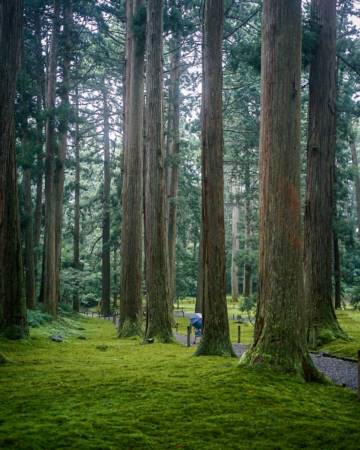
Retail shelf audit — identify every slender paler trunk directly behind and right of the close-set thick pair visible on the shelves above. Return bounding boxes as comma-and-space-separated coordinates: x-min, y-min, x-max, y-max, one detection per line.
167, 13, 181, 306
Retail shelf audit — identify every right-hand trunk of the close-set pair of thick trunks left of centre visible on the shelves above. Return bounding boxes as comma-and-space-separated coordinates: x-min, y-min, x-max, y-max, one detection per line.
145, 0, 172, 342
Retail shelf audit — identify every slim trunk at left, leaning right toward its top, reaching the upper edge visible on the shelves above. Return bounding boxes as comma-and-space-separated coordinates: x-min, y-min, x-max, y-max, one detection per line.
54, 0, 72, 302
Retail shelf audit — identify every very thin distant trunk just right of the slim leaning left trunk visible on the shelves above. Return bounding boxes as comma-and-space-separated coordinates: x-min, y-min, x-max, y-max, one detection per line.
73, 88, 81, 312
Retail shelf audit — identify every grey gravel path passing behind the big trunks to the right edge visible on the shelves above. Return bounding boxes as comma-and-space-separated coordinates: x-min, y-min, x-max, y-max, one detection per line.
175, 334, 358, 389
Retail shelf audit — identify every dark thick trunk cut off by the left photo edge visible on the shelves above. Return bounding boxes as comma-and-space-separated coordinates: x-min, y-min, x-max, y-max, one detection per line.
0, 0, 27, 339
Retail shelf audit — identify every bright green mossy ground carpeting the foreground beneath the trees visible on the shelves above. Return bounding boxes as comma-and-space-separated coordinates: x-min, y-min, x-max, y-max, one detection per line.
0, 315, 360, 450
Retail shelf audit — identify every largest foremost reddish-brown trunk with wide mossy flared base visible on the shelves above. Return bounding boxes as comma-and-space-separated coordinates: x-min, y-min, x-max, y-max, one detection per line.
243, 0, 317, 380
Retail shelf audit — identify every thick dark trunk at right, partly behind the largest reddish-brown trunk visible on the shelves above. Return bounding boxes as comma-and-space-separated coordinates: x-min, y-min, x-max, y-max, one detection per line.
304, 0, 344, 344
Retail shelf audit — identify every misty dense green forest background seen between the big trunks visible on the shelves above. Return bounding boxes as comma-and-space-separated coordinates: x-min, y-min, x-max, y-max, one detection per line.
9, 0, 360, 316
